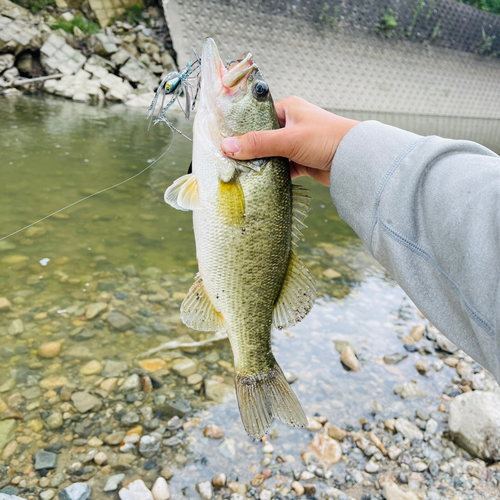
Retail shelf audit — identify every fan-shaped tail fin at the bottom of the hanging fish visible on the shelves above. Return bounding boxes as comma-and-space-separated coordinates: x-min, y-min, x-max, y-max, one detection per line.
235, 363, 307, 441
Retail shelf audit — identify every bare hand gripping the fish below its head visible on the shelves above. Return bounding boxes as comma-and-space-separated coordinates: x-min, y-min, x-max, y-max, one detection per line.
221, 97, 359, 186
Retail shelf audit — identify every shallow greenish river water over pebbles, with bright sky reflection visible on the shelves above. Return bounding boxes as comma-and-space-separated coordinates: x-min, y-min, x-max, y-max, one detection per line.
0, 97, 496, 497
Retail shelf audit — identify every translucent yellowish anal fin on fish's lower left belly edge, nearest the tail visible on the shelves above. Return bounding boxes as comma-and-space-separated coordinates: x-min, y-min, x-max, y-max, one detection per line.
181, 274, 224, 332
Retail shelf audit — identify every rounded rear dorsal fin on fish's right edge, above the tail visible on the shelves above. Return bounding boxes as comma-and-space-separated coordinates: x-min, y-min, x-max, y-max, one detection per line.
273, 250, 316, 330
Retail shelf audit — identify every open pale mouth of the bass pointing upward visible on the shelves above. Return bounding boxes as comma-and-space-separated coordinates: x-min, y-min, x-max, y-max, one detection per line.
201, 38, 257, 104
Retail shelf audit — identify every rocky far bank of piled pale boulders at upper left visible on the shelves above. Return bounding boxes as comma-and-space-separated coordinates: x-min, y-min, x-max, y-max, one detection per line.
0, 0, 175, 107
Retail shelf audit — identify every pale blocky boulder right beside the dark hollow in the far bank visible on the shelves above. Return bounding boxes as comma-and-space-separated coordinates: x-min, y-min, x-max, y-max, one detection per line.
40, 33, 87, 75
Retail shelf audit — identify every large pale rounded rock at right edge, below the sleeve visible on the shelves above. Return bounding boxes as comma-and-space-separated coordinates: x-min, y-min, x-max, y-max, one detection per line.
448, 391, 500, 461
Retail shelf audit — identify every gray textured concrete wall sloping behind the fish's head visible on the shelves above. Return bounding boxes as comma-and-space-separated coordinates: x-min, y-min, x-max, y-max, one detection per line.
164, 0, 500, 118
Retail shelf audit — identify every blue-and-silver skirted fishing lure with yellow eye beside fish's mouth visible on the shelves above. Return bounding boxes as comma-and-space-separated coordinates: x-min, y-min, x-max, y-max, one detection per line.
148, 48, 201, 140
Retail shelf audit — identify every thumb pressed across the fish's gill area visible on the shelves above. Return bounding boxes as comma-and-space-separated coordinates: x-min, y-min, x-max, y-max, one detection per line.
221, 128, 293, 160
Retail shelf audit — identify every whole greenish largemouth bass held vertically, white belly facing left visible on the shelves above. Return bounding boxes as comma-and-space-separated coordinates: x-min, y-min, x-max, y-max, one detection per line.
165, 39, 316, 439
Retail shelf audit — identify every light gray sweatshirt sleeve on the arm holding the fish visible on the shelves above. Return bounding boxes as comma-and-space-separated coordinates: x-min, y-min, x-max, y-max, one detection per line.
330, 121, 500, 381
